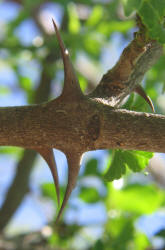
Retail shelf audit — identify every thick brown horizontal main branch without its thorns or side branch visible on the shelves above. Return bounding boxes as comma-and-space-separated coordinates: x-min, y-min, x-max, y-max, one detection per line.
0, 98, 165, 152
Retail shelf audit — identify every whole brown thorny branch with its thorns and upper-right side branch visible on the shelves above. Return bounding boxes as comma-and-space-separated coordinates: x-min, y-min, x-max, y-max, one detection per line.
0, 17, 165, 222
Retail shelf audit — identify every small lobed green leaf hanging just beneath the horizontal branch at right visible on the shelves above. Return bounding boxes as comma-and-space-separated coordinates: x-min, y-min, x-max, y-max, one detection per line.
104, 150, 153, 181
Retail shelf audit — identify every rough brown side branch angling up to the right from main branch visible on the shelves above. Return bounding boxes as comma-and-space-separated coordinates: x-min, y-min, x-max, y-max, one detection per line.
89, 17, 163, 107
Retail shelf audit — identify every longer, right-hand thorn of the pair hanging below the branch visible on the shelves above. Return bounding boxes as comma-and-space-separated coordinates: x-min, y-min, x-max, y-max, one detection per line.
55, 154, 81, 223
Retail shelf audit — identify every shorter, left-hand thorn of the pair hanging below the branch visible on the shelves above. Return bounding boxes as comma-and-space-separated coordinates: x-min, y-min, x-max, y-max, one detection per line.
37, 148, 60, 206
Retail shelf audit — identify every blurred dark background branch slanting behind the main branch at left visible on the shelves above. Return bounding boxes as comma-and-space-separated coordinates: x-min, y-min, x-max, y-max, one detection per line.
0, 52, 54, 231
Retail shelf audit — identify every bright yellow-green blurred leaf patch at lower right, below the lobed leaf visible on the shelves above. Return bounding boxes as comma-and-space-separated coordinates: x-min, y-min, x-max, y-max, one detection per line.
109, 184, 164, 214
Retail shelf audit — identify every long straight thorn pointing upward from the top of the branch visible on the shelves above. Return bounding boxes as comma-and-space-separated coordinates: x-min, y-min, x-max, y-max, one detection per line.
52, 19, 82, 97
